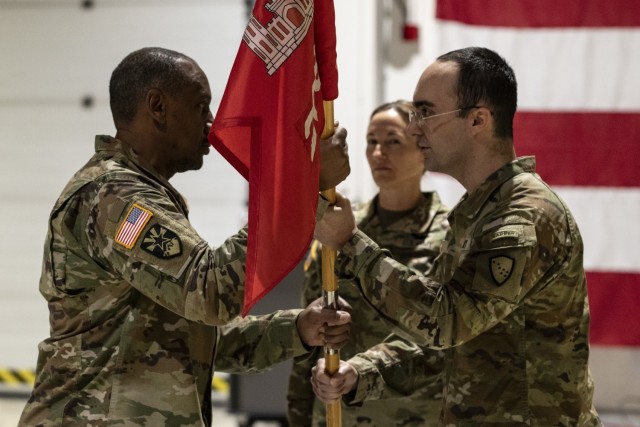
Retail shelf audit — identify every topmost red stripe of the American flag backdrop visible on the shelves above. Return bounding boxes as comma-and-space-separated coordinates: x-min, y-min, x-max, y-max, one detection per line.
436, 0, 640, 28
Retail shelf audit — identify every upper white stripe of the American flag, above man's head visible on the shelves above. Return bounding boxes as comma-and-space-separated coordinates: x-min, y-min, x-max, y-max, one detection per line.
437, 21, 640, 111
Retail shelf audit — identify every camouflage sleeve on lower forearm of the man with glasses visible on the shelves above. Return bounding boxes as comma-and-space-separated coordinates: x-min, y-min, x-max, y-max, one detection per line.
344, 334, 443, 406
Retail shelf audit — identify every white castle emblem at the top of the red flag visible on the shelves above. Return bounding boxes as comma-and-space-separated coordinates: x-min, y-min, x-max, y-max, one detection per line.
242, 0, 313, 75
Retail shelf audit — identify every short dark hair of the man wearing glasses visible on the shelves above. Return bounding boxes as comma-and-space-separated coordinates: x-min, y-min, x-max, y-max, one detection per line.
437, 47, 518, 138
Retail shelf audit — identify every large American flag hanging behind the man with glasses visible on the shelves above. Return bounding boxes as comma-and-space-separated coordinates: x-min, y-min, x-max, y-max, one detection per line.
425, 0, 640, 404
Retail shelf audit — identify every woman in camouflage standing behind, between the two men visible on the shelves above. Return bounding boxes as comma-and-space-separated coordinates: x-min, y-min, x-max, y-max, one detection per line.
287, 101, 449, 427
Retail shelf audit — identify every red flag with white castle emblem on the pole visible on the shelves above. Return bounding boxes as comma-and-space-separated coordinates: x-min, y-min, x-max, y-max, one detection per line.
209, 0, 338, 316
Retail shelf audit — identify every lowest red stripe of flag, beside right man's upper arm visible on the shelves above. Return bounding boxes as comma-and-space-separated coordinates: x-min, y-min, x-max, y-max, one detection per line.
587, 272, 640, 346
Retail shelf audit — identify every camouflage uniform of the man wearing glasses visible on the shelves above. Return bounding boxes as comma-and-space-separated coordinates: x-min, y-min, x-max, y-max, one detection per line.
337, 157, 601, 427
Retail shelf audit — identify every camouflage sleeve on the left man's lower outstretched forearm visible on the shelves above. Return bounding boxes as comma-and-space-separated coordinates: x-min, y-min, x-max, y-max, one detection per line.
215, 309, 308, 374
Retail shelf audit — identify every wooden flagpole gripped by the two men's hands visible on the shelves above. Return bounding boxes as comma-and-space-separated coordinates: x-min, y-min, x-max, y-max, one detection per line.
321, 101, 342, 427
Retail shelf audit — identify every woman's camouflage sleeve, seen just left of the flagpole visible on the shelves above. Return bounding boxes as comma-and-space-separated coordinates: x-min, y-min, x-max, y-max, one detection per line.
287, 241, 322, 427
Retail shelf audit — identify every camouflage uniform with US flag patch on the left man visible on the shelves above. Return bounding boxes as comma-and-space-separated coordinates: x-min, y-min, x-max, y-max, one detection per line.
20, 136, 316, 426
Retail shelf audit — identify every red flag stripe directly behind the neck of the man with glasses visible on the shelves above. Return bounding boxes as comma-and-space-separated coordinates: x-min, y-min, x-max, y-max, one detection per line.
514, 111, 640, 187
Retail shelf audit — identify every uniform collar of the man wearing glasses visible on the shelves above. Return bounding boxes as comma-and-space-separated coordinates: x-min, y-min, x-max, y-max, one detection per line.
449, 156, 536, 222
